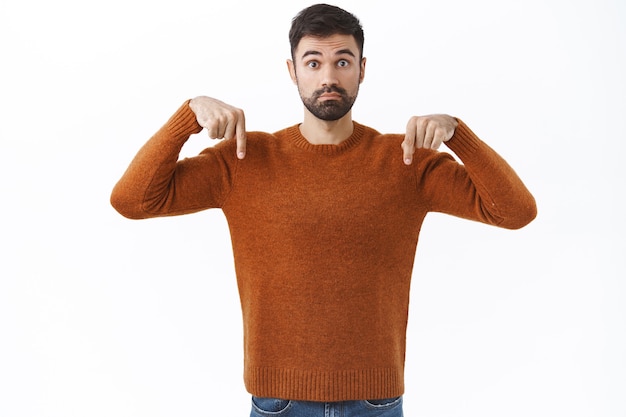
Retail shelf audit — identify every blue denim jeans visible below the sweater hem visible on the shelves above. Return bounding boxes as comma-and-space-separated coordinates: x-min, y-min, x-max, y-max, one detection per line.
250, 396, 403, 417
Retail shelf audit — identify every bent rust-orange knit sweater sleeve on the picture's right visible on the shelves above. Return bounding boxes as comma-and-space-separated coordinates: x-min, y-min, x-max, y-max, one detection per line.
418, 120, 537, 229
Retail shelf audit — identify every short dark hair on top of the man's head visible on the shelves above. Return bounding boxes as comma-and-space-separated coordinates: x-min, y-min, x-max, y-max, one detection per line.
289, 3, 364, 59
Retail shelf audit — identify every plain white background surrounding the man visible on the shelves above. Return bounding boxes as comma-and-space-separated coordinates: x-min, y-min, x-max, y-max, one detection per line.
0, 0, 626, 417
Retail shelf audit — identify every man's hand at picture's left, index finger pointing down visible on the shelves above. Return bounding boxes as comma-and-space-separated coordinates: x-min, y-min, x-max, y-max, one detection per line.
189, 96, 246, 159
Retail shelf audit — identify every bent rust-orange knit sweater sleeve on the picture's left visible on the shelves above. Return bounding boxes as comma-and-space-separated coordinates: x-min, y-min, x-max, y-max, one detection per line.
111, 101, 235, 219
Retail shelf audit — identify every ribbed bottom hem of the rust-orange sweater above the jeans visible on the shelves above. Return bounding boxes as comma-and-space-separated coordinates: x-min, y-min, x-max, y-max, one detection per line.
244, 367, 404, 402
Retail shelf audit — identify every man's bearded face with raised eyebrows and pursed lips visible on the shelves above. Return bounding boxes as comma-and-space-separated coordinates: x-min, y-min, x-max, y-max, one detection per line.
288, 35, 365, 121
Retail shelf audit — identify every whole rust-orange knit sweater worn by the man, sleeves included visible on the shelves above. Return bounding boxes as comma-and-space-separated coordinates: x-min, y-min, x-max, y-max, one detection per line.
111, 103, 536, 401
